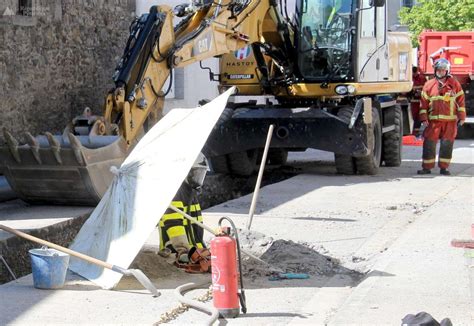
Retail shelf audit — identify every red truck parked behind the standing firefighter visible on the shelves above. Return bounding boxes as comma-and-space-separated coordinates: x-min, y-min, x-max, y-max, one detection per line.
418, 30, 474, 138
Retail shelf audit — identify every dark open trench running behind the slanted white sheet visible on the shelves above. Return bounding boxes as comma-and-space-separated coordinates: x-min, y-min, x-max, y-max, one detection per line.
0, 167, 296, 284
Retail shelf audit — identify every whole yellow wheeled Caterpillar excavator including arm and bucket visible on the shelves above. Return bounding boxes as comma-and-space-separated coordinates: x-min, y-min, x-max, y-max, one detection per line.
0, 0, 412, 205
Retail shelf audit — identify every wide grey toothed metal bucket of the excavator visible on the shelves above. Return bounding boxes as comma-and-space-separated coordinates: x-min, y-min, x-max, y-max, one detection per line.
0, 130, 130, 206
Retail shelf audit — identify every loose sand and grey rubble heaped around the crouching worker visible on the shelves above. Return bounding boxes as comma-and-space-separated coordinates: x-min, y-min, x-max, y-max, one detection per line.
115, 230, 366, 290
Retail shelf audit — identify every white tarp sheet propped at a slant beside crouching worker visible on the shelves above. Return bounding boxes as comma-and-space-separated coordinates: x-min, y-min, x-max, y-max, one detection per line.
69, 89, 233, 289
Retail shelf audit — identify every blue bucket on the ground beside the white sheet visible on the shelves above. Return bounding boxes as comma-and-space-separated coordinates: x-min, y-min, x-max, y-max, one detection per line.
29, 247, 69, 289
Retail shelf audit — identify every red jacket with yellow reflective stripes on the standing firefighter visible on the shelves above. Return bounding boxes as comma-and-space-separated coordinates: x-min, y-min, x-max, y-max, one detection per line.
420, 76, 466, 121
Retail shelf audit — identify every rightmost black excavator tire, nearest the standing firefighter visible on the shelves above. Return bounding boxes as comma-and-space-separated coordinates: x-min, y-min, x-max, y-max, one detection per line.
382, 105, 403, 166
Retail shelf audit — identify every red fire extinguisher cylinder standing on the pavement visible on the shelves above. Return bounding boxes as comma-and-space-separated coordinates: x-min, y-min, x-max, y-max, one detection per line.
211, 235, 240, 318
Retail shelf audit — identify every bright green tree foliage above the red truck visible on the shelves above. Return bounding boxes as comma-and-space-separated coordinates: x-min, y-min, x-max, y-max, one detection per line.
399, 0, 474, 46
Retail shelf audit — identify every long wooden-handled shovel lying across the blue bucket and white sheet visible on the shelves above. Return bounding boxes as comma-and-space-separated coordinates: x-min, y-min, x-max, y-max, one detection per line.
0, 224, 160, 297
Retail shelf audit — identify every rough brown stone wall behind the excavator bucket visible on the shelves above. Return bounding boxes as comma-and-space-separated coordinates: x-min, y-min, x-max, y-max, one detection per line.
0, 0, 135, 138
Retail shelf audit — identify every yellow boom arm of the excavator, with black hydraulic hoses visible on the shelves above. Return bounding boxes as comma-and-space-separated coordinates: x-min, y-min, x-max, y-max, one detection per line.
109, 0, 279, 144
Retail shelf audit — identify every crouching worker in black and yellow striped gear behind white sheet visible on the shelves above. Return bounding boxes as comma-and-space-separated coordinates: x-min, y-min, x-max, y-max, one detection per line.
159, 154, 211, 273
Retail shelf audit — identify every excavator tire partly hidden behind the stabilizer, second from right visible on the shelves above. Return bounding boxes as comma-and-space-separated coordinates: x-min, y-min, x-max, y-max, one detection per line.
355, 108, 382, 175
